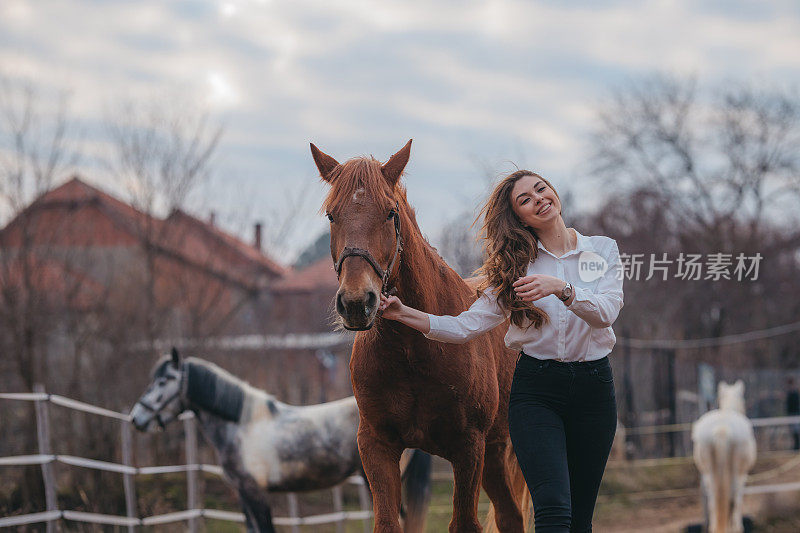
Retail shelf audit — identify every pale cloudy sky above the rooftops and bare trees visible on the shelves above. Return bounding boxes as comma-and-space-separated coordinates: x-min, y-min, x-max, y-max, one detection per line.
0, 0, 800, 257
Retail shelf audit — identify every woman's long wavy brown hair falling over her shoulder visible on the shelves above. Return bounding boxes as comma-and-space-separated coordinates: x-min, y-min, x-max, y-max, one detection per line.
476, 170, 561, 329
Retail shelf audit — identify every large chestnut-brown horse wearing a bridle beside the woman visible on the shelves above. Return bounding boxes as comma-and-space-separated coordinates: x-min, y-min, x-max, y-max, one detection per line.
311, 141, 529, 533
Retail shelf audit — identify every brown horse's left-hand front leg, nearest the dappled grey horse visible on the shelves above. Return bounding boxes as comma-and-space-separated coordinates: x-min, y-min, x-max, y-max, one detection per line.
358, 421, 403, 533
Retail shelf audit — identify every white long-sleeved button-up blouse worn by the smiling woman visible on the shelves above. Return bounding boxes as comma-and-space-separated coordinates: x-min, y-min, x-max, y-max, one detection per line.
425, 230, 623, 361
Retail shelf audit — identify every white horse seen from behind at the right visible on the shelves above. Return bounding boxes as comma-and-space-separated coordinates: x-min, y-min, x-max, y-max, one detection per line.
692, 380, 756, 533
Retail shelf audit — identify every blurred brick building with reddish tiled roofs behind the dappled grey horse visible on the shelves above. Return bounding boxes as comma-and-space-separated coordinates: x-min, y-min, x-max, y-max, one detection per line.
0, 177, 350, 403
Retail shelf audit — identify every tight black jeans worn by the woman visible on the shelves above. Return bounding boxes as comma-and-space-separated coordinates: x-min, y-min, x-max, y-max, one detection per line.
508, 354, 617, 533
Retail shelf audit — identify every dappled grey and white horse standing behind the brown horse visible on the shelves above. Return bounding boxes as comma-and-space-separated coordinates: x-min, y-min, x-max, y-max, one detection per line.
131, 348, 431, 533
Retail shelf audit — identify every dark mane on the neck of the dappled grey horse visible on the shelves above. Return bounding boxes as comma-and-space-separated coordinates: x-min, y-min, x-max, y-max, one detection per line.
183, 357, 248, 422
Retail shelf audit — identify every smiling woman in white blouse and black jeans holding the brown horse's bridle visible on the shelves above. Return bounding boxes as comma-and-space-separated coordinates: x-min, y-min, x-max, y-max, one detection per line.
380, 170, 623, 533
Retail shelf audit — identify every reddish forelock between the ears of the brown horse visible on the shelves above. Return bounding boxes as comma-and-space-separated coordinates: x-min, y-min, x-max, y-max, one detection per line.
322, 156, 406, 213
